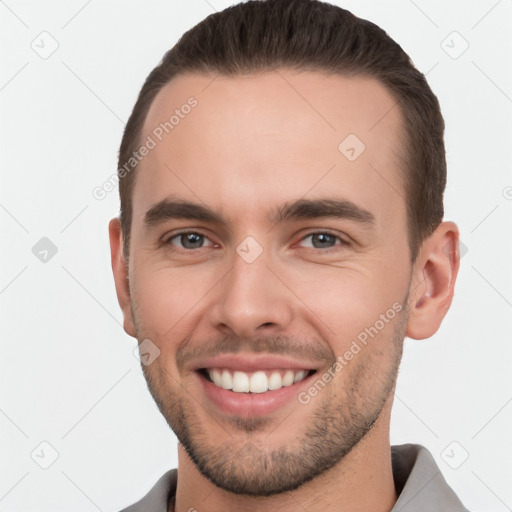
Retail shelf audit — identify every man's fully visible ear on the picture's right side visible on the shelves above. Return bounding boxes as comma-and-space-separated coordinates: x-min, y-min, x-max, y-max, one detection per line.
405, 222, 460, 339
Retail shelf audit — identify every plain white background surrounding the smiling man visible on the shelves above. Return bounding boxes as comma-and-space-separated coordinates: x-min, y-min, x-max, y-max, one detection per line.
0, 0, 512, 512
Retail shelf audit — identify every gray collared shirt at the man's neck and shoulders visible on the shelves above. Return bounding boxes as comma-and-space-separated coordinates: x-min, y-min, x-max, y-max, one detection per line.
122, 444, 468, 512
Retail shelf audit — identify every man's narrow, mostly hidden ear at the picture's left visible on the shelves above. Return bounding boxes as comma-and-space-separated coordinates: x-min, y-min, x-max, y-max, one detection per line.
108, 217, 136, 338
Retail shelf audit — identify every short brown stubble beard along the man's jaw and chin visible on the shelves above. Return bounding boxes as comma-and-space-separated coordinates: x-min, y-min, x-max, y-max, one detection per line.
132, 302, 407, 496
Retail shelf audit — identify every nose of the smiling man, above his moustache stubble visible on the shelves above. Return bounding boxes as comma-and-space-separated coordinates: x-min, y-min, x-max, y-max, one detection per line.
209, 250, 293, 337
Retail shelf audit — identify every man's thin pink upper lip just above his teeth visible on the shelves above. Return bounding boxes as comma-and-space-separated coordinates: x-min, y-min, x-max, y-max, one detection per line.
192, 354, 318, 372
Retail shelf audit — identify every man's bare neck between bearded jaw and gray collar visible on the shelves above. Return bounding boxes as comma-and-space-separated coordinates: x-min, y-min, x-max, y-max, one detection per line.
170, 403, 397, 512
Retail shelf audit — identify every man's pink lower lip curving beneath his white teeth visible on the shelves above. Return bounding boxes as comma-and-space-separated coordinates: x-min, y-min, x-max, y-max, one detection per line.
197, 373, 314, 418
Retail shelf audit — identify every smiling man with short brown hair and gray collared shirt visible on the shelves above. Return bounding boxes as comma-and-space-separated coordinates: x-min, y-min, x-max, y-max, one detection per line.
109, 0, 466, 512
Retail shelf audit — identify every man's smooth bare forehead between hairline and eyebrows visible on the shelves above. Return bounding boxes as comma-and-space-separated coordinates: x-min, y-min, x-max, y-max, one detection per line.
133, 69, 403, 228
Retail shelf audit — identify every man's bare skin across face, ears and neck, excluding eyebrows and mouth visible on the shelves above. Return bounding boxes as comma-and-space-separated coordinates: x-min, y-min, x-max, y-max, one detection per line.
109, 69, 459, 512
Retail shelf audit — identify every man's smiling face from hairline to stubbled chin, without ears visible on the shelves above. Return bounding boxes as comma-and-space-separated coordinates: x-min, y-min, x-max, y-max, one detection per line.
125, 70, 411, 495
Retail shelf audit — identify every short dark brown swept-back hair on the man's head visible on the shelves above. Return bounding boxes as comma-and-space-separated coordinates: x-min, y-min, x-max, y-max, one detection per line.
118, 0, 446, 261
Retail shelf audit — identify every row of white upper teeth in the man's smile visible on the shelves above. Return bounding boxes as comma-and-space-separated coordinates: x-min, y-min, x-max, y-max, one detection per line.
208, 368, 307, 393
